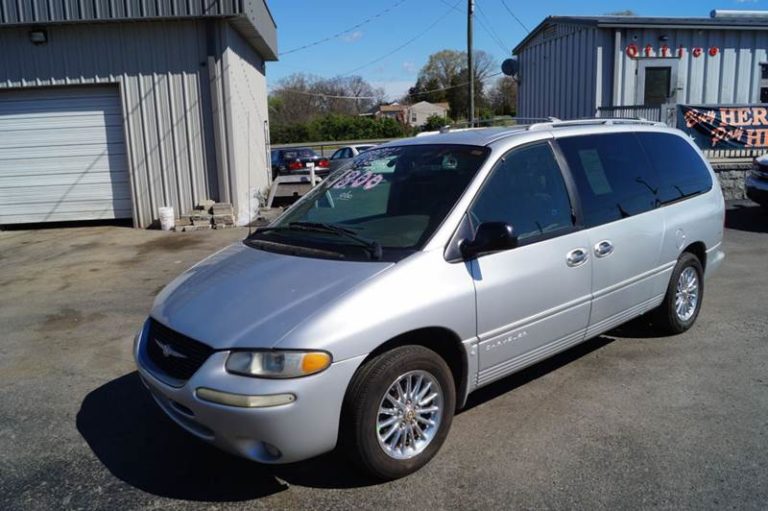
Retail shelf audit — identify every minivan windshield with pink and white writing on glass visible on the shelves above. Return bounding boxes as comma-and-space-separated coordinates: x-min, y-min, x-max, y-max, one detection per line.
249, 144, 490, 260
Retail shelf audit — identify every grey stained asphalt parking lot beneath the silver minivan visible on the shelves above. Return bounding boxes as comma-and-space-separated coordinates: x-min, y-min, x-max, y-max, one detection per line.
0, 203, 768, 510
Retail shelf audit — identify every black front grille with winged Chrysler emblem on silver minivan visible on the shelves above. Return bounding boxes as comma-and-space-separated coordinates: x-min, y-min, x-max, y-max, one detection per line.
147, 318, 213, 380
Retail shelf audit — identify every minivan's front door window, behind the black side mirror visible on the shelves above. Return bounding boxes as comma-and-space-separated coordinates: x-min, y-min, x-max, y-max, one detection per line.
469, 143, 573, 244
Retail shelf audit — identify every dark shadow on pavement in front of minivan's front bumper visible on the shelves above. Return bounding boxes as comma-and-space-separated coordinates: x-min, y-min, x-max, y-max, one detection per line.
77, 372, 375, 502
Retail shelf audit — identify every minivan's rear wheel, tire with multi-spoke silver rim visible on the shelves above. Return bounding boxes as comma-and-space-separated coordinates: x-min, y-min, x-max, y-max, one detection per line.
653, 252, 704, 334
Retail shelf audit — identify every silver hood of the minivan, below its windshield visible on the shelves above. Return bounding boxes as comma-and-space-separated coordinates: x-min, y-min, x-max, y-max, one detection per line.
151, 243, 394, 349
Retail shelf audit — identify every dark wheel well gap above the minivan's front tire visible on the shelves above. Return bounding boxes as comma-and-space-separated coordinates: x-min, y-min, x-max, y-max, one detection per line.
363, 327, 467, 409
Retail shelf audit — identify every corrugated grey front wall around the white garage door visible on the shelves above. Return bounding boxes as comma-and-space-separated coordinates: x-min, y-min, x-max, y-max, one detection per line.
0, 21, 216, 227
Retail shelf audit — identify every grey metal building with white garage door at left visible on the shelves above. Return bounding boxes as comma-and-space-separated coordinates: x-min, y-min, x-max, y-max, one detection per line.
0, 0, 277, 227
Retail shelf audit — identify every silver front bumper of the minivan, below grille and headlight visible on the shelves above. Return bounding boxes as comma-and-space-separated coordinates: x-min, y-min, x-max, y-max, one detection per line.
134, 327, 365, 463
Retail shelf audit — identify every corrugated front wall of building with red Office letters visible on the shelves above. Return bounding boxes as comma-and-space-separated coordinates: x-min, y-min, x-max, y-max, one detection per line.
616, 29, 768, 105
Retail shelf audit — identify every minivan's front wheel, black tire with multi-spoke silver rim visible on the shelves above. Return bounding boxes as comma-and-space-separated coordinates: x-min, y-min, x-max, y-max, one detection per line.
341, 346, 456, 480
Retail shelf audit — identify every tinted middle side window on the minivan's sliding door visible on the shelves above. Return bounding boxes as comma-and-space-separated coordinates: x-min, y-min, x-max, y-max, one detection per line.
557, 133, 658, 227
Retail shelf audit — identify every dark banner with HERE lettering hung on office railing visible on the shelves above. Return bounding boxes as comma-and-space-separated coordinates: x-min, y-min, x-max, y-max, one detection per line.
677, 105, 768, 149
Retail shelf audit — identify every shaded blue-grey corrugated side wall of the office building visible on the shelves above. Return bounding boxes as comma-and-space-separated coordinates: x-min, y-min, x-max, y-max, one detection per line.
517, 24, 612, 119
